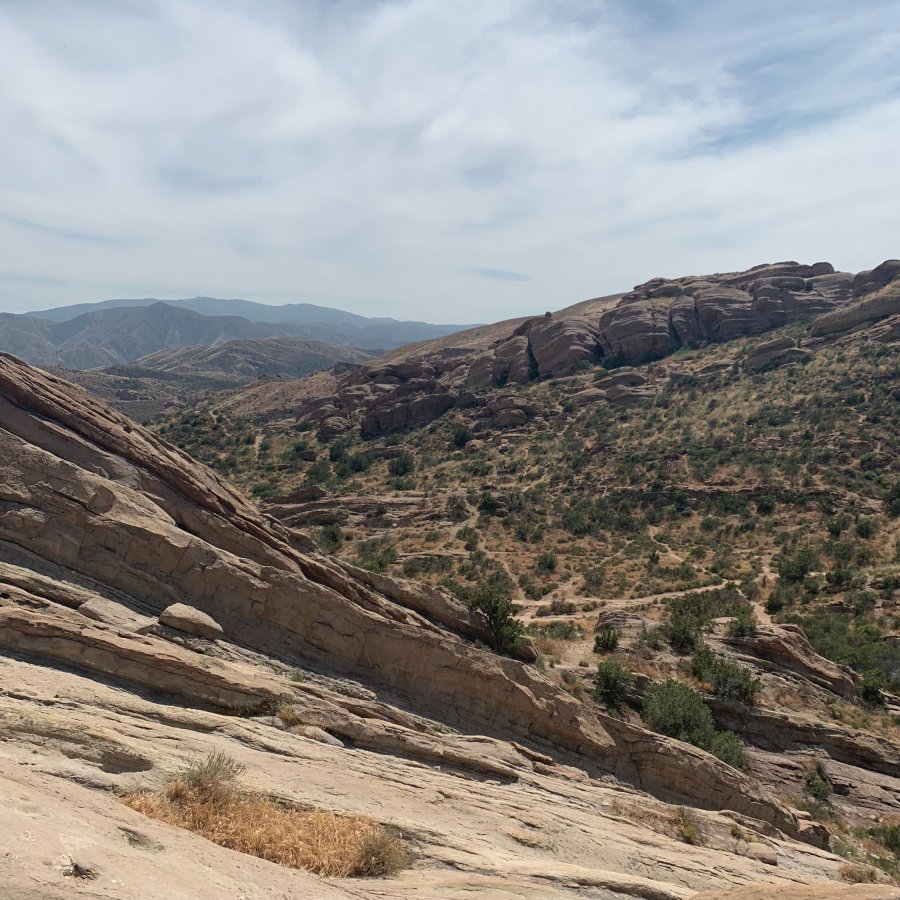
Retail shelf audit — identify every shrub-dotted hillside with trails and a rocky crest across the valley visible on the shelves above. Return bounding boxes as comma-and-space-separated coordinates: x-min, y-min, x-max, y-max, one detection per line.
144, 262, 900, 875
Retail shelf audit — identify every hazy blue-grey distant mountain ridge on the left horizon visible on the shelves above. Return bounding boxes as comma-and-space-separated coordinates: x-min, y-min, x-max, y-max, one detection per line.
0, 297, 478, 369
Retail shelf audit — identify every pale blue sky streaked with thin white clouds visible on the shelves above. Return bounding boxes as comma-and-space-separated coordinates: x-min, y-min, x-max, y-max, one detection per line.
0, 0, 900, 323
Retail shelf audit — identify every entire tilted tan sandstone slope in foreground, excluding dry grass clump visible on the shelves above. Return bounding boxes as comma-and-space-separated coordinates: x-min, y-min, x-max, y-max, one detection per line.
0, 356, 897, 900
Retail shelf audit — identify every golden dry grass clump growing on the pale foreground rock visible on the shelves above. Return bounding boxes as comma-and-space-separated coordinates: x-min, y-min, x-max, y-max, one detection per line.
124, 754, 410, 878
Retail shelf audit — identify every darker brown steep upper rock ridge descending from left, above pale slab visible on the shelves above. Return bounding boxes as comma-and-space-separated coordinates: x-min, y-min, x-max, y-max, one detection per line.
0, 357, 800, 834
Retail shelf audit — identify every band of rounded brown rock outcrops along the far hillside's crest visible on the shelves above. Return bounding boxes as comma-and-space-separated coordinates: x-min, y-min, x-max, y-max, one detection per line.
276, 260, 900, 441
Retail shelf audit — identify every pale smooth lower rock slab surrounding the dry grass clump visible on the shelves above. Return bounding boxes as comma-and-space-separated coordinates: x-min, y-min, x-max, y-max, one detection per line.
0, 656, 864, 900
